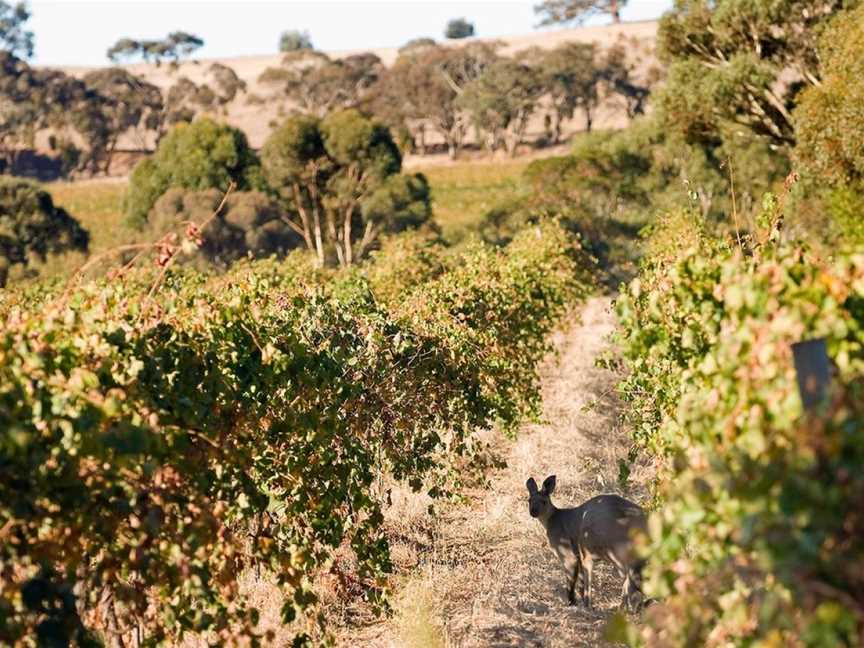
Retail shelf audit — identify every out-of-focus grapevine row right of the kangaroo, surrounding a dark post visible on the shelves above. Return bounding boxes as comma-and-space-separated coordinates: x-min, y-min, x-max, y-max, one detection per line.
616, 201, 864, 648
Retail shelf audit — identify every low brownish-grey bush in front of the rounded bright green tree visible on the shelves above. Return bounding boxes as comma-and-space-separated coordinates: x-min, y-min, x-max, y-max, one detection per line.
147, 187, 300, 267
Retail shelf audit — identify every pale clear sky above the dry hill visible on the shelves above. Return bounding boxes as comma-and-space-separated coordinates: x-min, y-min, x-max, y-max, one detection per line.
29, 0, 672, 66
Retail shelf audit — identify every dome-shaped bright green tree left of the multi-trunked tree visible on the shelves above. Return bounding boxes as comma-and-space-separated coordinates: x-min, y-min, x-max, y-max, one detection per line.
125, 118, 262, 226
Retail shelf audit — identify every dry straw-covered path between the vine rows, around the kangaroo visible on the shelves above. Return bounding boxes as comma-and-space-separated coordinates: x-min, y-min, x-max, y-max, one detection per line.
340, 297, 650, 648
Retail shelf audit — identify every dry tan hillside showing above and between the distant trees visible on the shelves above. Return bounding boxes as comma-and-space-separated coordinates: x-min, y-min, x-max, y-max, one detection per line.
64, 21, 657, 148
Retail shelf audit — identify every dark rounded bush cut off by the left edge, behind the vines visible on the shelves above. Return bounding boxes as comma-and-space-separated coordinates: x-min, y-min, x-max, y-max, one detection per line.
0, 177, 90, 287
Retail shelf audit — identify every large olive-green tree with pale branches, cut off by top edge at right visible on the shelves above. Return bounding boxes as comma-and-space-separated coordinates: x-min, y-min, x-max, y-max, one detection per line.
658, 0, 850, 148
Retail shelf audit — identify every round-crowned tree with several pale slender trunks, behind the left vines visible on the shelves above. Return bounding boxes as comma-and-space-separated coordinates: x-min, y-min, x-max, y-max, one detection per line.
261, 110, 430, 265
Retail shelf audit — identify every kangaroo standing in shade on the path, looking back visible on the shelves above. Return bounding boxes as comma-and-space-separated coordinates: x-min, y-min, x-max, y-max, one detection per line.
525, 475, 646, 609
